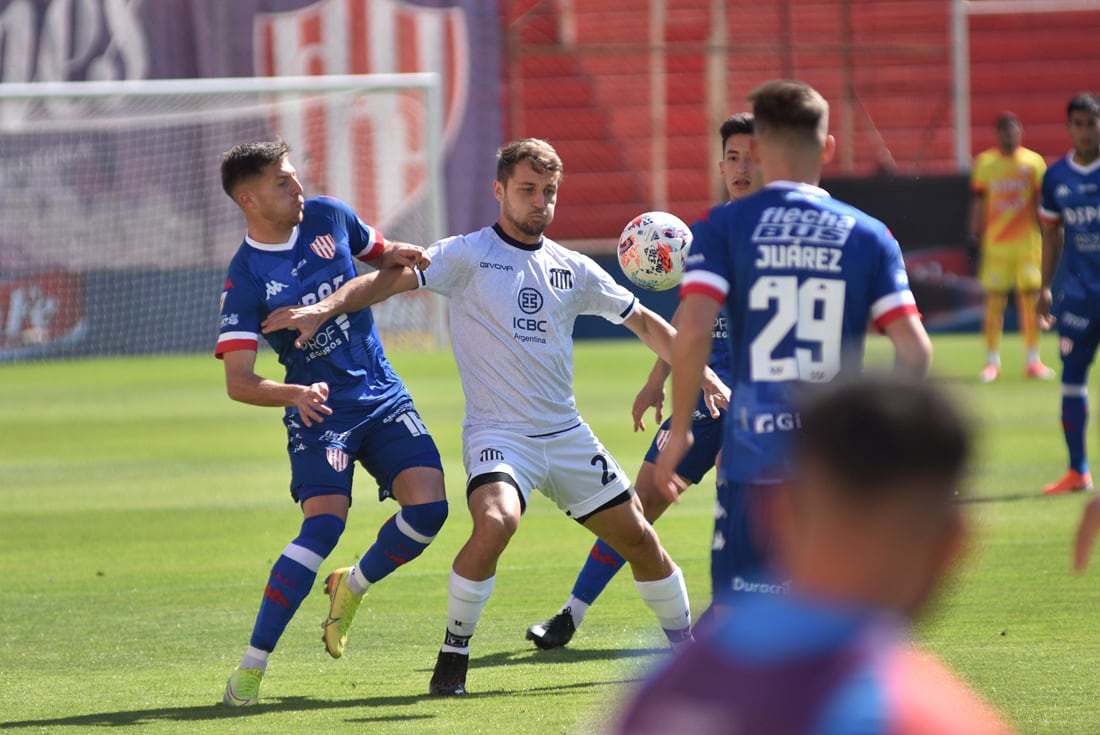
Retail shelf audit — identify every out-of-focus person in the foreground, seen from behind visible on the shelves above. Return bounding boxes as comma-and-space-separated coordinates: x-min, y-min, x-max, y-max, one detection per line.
614, 373, 1010, 735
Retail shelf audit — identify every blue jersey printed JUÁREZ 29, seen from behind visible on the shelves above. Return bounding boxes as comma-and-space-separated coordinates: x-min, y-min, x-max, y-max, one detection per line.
680, 182, 917, 482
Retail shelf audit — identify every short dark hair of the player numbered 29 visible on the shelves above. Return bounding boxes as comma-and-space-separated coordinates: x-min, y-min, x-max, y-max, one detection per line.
748, 79, 828, 145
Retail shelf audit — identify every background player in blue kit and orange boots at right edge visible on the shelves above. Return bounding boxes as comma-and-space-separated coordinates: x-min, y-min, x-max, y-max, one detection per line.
1036, 92, 1100, 495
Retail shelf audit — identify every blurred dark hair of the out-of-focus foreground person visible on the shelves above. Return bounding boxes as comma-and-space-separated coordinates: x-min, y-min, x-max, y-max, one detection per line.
795, 376, 972, 503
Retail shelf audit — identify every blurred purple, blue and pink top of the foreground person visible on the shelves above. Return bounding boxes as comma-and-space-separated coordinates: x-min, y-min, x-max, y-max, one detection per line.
614, 596, 1011, 735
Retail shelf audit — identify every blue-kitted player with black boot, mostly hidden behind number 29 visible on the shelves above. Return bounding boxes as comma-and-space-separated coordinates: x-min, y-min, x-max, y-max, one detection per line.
527, 112, 759, 650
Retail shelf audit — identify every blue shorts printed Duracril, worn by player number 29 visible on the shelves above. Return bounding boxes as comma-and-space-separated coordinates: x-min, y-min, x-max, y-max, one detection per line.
711, 482, 790, 605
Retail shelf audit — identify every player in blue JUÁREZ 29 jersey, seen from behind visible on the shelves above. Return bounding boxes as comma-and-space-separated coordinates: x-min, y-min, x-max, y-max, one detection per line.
657, 80, 932, 599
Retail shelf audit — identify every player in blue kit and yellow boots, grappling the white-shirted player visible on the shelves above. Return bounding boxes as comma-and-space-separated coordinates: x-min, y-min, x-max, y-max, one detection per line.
216, 142, 447, 707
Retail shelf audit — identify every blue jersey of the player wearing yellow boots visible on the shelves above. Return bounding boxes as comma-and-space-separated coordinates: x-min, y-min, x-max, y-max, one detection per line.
215, 197, 405, 419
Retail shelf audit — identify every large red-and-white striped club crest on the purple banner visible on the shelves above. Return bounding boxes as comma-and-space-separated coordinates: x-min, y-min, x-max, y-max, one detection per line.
253, 0, 470, 230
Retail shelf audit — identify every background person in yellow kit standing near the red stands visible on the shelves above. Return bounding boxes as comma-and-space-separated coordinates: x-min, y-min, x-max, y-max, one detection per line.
969, 112, 1054, 383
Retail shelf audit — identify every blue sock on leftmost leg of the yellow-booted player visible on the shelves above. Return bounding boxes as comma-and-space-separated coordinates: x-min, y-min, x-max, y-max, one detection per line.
249, 515, 344, 651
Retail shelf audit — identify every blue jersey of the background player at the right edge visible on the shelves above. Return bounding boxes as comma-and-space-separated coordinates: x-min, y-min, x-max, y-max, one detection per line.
1040, 152, 1100, 308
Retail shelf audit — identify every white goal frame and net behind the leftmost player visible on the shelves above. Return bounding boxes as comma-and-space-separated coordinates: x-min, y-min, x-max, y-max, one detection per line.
0, 74, 446, 362
